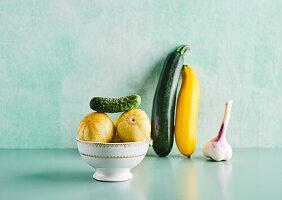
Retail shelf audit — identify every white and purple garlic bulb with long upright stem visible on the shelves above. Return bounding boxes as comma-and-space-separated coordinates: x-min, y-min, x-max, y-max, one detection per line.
203, 100, 232, 161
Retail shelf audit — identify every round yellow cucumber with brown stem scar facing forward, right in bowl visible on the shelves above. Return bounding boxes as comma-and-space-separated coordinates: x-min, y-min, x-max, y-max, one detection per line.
116, 109, 151, 142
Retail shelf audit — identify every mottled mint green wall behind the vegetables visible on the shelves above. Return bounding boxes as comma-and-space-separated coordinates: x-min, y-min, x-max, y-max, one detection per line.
0, 0, 282, 148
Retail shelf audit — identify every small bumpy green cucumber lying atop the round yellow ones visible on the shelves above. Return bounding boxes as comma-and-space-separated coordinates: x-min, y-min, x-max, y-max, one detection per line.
90, 94, 141, 113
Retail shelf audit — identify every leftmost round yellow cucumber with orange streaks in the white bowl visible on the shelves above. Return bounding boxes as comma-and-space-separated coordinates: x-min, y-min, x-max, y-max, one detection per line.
77, 112, 115, 142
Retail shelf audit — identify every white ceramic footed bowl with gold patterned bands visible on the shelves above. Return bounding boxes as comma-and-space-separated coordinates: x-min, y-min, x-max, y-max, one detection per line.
76, 138, 150, 181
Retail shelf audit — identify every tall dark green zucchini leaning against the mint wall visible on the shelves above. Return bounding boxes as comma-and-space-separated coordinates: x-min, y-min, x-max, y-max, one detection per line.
152, 45, 189, 156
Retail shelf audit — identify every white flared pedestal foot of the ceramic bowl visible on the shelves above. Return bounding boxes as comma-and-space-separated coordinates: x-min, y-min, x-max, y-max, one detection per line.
93, 168, 133, 181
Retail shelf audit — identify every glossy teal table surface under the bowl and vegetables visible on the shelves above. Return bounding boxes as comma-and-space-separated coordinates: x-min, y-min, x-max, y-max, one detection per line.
0, 149, 282, 200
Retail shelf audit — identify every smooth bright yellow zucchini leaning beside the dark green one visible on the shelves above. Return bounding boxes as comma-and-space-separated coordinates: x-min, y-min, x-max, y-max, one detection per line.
175, 65, 200, 157
